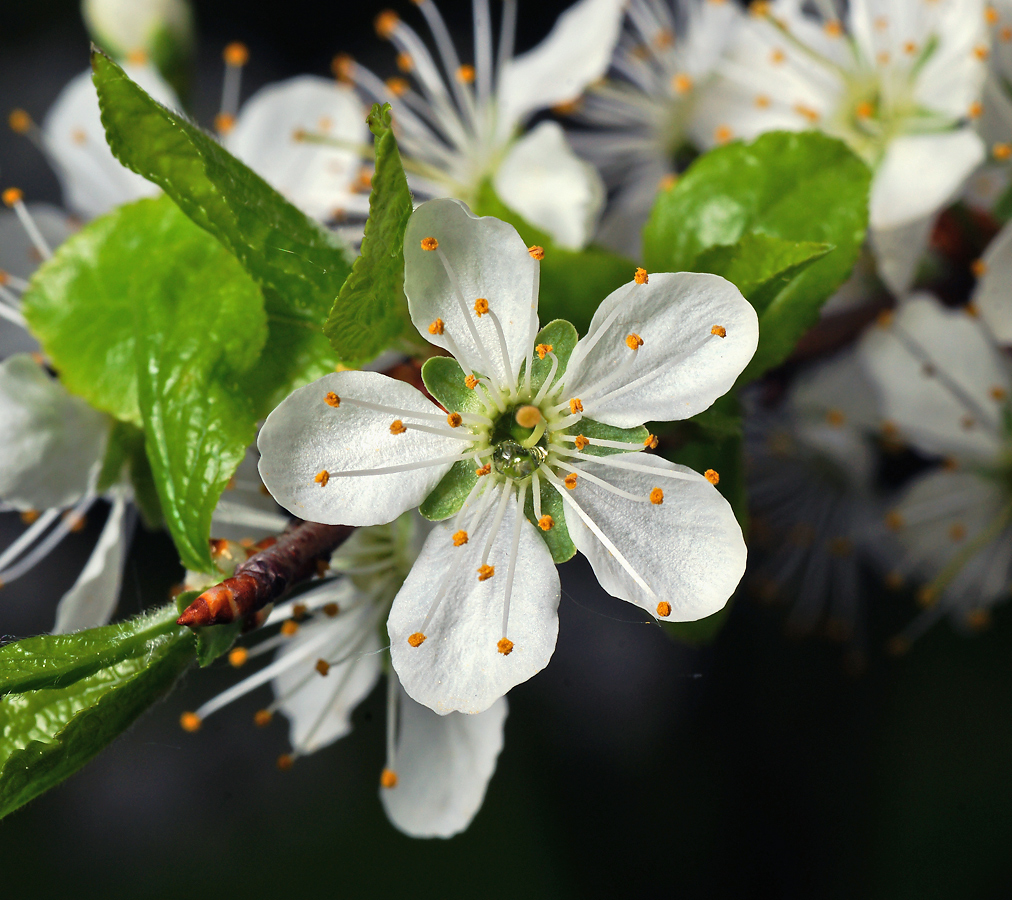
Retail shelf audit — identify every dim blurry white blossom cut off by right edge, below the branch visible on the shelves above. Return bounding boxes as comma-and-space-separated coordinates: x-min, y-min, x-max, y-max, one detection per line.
861, 295, 1012, 649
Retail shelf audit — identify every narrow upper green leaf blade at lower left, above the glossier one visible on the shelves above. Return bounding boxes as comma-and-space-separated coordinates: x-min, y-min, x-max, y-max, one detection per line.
0, 605, 178, 696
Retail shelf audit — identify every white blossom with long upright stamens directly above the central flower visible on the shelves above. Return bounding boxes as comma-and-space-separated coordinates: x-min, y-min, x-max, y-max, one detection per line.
335, 0, 622, 248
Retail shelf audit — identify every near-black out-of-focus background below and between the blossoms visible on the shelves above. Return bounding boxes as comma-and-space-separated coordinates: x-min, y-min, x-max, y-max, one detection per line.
0, 0, 1012, 900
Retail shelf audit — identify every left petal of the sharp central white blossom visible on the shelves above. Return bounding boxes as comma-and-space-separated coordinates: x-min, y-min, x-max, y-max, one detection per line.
257, 372, 468, 525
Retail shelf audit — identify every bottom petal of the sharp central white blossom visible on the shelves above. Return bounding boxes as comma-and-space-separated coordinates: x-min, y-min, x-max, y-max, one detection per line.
387, 487, 561, 716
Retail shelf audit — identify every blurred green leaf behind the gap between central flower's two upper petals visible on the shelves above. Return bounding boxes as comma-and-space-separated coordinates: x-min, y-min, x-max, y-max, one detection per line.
475, 182, 636, 334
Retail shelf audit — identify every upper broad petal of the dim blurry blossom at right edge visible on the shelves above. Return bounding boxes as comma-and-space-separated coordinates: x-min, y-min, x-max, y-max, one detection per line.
860, 295, 1012, 460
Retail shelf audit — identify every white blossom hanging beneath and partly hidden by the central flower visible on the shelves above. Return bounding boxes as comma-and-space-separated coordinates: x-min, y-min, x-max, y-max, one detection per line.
181, 513, 507, 837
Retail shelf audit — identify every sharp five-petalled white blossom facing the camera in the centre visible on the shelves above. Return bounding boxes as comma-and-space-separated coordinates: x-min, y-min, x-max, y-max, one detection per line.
259, 199, 758, 714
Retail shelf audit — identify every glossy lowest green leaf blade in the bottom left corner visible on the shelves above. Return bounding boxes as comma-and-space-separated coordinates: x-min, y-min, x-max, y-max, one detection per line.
0, 619, 193, 818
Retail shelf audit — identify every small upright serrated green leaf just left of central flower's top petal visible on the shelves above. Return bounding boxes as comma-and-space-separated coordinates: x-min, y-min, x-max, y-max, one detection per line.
324, 103, 415, 365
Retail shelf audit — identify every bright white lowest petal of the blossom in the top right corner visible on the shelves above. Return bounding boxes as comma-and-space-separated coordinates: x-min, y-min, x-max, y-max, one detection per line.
868, 128, 985, 230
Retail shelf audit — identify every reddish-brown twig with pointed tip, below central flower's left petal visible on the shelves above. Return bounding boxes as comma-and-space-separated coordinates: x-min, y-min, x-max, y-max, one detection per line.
176, 522, 354, 627
